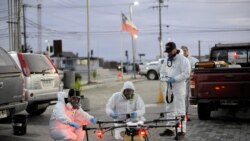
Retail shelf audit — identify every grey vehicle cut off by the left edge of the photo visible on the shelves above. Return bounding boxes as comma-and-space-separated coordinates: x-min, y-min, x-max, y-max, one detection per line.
0, 47, 28, 119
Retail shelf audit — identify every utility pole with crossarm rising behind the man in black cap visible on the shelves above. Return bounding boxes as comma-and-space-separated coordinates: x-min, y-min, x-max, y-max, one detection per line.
153, 0, 168, 58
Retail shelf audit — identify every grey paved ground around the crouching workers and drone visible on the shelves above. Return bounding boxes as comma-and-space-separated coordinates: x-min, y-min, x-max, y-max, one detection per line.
0, 79, 250, 141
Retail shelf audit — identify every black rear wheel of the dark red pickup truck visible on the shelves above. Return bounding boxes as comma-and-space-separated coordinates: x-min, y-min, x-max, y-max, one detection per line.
198, 103, 211, 120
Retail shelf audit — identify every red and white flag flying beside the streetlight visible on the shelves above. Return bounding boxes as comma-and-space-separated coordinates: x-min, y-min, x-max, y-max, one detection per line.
122, 13, 138, 37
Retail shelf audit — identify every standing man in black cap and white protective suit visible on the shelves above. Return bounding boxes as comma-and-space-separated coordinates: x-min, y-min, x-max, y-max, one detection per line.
159, 42, 190, 139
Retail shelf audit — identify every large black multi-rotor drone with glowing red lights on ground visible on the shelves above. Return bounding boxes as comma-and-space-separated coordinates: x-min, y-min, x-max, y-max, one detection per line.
83, 113, 184, 141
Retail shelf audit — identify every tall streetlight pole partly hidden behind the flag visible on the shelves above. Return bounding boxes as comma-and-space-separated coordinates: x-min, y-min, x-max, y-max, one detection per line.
129, 1, 139, 78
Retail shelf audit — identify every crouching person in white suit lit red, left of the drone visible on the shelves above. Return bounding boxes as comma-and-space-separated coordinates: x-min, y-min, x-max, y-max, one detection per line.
49, 89, 97, 141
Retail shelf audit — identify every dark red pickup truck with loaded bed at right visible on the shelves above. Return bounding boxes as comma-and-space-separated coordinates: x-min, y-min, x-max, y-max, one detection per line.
190, 43, 250, 120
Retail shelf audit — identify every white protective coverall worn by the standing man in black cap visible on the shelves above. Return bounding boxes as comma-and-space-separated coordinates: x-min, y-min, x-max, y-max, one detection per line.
160, 54, 191, 132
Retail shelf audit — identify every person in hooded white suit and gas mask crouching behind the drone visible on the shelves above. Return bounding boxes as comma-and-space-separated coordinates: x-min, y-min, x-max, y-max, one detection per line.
106, 81, 145, 140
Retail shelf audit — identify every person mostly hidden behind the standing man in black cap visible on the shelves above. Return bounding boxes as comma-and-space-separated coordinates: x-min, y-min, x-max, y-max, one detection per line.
181, 46, 199, 121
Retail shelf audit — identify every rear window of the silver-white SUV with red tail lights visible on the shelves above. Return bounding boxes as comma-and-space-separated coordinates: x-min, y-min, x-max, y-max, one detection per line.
24, 54, 55, 73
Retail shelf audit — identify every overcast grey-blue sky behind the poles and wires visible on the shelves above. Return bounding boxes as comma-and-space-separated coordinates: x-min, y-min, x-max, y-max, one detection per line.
0, 0, 250, 60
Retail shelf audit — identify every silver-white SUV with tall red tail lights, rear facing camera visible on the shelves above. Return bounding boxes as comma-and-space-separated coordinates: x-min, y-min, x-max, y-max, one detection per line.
9, 52, 61, 115
